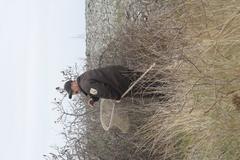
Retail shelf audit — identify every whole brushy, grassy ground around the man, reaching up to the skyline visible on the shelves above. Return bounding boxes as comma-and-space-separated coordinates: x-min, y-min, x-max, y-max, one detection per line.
74, 0, 240, 160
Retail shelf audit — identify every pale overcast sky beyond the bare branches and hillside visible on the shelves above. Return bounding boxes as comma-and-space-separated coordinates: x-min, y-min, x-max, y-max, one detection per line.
0, 0, 85, 160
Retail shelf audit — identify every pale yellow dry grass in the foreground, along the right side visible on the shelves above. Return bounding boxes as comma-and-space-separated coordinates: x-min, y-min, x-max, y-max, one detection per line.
132, 0, 240, 159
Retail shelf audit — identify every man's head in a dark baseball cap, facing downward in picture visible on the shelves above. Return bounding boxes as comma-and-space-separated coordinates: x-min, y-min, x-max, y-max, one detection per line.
64, 80, 80, 99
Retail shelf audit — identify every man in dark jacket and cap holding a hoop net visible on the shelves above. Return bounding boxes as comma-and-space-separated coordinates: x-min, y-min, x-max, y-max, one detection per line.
64, 65, 134, 106
